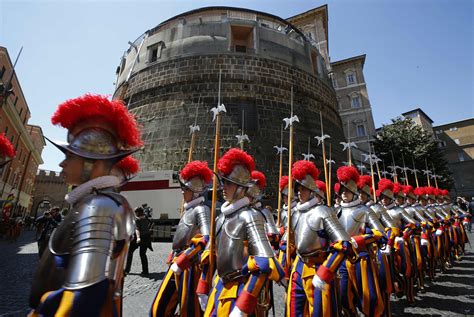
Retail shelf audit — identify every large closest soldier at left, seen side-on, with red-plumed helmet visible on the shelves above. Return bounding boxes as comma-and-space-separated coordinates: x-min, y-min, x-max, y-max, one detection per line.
30, 94, 142, 316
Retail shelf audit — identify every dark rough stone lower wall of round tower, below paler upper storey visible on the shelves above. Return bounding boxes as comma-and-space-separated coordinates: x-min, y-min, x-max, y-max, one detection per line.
120, 53, 345, 198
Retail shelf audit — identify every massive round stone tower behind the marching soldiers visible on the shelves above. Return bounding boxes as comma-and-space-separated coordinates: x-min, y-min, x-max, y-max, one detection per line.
114, 7, 344, 199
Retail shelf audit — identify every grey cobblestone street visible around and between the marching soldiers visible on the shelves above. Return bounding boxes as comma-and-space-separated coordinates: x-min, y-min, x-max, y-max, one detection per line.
0, 231, 474, 316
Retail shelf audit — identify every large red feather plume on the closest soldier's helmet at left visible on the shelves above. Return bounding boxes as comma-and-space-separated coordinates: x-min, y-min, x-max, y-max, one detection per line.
51, 94, 143, 147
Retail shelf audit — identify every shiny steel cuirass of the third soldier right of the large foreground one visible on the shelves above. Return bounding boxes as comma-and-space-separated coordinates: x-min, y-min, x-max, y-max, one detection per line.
291, 204, 349, 256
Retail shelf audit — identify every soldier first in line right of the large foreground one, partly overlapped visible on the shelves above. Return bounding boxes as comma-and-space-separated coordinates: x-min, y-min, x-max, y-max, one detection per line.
150, 161, 212, 317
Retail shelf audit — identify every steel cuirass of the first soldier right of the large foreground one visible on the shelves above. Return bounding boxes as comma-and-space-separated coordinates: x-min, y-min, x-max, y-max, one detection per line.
173, 203, 210, 252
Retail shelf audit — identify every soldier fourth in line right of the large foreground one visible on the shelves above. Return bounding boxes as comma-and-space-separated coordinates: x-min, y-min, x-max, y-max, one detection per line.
337, 166, 386, 316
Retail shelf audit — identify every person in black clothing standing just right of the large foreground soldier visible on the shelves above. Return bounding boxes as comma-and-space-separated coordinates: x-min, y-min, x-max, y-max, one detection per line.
125, 207, 153, 275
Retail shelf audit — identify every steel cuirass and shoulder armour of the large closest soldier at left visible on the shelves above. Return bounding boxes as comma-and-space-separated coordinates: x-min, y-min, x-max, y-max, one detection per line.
49, 190, 135, 290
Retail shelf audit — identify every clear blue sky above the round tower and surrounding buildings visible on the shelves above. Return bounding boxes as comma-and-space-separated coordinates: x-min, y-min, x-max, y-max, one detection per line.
0, 0, 474, 170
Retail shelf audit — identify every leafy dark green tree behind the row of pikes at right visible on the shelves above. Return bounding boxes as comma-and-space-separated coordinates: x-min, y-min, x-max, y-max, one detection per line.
374, 117, 453, 189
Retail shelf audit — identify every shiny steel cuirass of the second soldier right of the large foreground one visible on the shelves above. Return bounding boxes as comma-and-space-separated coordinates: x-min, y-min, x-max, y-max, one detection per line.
216, 206, 274, 278
